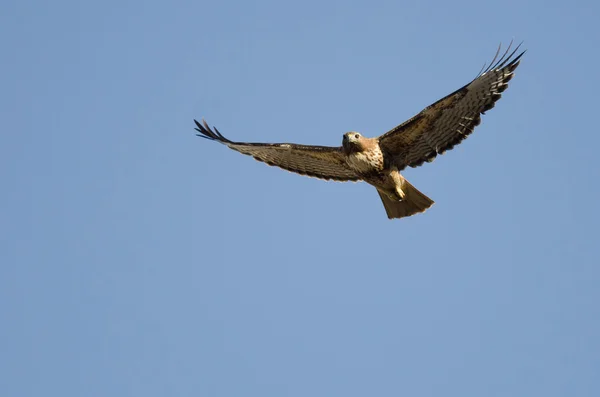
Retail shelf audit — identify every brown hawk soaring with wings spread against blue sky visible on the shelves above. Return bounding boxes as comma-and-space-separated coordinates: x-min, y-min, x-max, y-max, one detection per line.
194, 45, 525, 219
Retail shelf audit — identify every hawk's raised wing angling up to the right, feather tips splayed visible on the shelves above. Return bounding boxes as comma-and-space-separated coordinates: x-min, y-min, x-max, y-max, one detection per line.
379, 44, 525, 170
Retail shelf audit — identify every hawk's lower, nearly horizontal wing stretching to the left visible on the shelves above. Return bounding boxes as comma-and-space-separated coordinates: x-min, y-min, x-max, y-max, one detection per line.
194, 120, 360, 181
